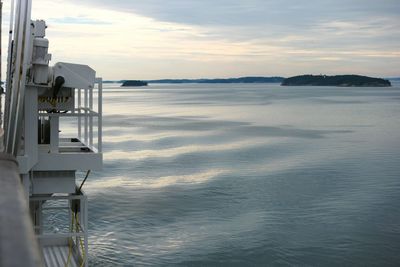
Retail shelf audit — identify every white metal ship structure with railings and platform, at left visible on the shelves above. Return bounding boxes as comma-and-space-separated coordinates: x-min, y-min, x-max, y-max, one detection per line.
4, 0, 102, 266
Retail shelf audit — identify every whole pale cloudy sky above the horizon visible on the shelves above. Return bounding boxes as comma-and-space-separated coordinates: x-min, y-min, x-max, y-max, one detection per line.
2, 0, 400, 79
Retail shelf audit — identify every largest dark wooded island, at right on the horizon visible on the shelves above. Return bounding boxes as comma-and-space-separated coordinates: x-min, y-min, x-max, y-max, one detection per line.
281, 75, 392, 87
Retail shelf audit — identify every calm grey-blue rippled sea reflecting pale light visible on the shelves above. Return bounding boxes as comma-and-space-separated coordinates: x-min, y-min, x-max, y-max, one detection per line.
85, 84, 400, 266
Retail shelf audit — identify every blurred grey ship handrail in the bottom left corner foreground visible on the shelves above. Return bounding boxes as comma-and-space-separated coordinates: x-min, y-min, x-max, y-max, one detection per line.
0, 153, 43, 267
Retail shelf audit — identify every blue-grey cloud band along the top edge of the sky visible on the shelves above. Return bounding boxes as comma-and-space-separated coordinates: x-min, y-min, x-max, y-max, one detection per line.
69, 0, 400, 28
